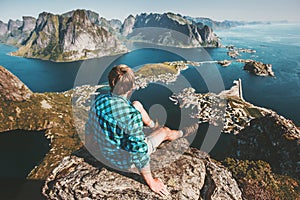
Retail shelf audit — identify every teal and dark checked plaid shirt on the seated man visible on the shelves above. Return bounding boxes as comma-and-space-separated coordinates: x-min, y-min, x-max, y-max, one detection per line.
86, 94, 150, 170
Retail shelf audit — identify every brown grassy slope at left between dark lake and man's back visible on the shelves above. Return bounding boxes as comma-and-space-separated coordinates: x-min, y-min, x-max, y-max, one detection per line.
0, 67, 82, 180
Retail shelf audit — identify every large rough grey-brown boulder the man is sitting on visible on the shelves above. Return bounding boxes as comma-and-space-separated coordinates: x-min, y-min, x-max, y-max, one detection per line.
43, 139, 242, 199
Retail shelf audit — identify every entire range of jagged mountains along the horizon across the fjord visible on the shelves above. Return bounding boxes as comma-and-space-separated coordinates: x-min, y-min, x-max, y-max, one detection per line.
0, 10, 278, 62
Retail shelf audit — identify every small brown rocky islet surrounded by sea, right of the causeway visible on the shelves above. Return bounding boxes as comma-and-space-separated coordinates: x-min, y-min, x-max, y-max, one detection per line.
244, 60, 274, 76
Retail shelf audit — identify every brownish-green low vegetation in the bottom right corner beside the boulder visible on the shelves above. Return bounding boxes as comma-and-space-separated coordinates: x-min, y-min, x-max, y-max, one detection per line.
222, 158, 300, 199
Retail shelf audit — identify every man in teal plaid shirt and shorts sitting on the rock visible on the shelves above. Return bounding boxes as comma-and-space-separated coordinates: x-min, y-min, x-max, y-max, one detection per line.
86, 65, 198, 196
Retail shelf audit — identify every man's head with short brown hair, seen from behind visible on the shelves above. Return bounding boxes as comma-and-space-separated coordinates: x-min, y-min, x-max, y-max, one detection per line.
108, 64, 135, 95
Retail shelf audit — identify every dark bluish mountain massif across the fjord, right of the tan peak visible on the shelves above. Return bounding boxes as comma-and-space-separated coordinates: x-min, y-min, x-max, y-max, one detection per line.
121, 13, 220, 47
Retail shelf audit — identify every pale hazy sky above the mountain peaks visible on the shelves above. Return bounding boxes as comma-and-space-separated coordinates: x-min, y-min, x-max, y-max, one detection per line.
0, 0, 300, 22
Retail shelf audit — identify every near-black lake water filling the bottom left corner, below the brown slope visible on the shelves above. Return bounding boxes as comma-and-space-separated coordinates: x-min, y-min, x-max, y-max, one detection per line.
0, 130, 50, 199
